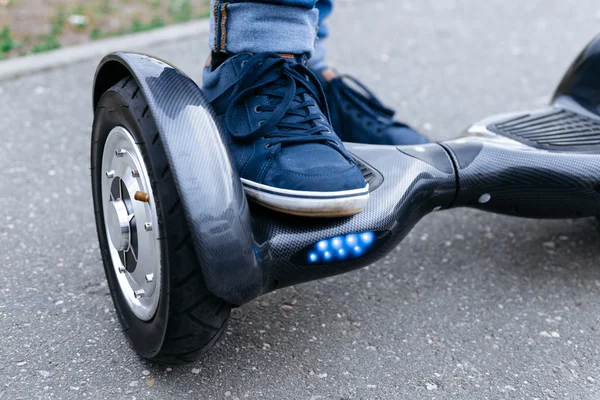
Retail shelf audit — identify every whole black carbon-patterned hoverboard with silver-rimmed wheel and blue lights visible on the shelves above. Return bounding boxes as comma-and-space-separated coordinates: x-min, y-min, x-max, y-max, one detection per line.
91, 36, 600, 363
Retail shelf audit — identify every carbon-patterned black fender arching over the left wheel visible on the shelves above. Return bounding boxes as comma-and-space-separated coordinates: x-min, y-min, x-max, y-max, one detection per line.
93, 52, 265, 305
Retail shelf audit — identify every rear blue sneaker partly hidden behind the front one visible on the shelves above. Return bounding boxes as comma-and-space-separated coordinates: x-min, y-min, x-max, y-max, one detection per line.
313, 68, 429, 145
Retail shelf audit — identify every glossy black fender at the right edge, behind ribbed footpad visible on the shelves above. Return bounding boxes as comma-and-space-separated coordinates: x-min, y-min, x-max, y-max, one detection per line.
551, 35, 600, 118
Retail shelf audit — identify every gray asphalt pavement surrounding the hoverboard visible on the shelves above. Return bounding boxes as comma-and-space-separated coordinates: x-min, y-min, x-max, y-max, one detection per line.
0, 0, 600, 400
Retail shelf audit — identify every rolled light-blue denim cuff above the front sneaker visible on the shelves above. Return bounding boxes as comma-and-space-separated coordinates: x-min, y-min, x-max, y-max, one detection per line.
209, 0, 319, 56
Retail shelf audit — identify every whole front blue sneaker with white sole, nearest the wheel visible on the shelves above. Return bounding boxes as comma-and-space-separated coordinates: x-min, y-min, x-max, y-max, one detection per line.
203, 53, 369, 217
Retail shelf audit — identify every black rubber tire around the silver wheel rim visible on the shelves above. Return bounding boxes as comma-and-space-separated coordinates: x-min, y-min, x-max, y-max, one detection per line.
91, 77, 231, 364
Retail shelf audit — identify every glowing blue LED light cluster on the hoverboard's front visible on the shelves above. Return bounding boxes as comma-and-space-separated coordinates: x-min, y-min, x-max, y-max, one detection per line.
307, 232, 375, 264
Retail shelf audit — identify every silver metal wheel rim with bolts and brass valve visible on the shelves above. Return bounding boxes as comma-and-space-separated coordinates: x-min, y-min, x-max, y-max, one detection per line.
102, 126, 161, 321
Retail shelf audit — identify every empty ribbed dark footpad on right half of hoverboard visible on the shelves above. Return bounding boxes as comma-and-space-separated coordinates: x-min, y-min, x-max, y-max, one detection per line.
488, 107, 600, 153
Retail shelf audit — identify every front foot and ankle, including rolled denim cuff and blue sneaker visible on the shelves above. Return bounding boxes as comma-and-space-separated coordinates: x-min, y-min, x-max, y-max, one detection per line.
203, 0, 369, 217
